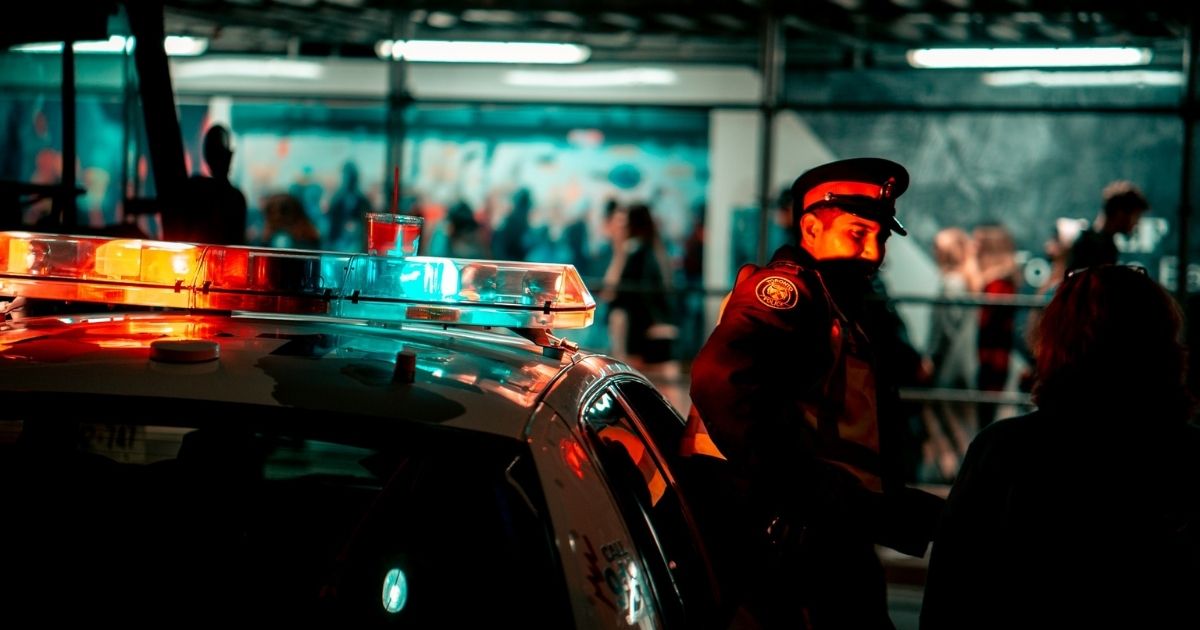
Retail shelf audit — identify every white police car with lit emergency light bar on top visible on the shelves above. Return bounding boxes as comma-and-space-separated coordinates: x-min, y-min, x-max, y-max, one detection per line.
0, 232, 718, 628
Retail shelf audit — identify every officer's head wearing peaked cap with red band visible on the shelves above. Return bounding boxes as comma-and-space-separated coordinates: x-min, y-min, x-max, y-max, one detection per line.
792, 157, 908, 266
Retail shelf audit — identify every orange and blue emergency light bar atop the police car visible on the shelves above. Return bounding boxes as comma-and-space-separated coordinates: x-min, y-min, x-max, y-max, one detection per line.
0, 232, 595, 329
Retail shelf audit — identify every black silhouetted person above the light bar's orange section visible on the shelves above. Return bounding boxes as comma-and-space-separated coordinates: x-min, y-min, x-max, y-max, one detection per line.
162, 125, 246, 245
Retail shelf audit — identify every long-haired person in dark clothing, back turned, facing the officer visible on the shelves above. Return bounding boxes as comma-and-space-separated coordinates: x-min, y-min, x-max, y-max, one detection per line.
920, 265, 1200, 629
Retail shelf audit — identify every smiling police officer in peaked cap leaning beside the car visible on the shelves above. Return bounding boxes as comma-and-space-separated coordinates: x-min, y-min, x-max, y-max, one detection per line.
680, 158, 941, 630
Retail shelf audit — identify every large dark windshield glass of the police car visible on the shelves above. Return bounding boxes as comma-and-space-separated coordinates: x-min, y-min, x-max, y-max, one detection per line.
0, 396, 570, 628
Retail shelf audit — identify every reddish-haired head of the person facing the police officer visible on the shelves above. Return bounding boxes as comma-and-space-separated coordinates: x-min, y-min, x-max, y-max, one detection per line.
1033, 265, 1189, 419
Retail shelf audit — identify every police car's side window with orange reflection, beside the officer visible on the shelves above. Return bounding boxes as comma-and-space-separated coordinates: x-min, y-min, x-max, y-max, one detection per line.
584, 380, 715, 626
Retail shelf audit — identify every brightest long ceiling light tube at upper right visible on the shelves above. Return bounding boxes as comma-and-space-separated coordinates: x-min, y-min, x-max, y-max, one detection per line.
906, 47, 1153, 68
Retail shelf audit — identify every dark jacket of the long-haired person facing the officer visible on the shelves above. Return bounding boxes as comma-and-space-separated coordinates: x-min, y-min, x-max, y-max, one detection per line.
920, 406, 1200, 630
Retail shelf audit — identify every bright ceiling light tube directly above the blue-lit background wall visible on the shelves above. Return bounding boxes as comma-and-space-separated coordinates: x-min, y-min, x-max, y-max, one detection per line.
376, 40, 592, 64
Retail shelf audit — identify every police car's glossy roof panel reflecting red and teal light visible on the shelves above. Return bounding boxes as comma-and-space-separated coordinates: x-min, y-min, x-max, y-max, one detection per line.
0, 312, 590, 438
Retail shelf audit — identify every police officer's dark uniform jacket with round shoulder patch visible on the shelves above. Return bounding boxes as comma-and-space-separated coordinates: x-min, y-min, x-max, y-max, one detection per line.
691, 246, 941, 626
